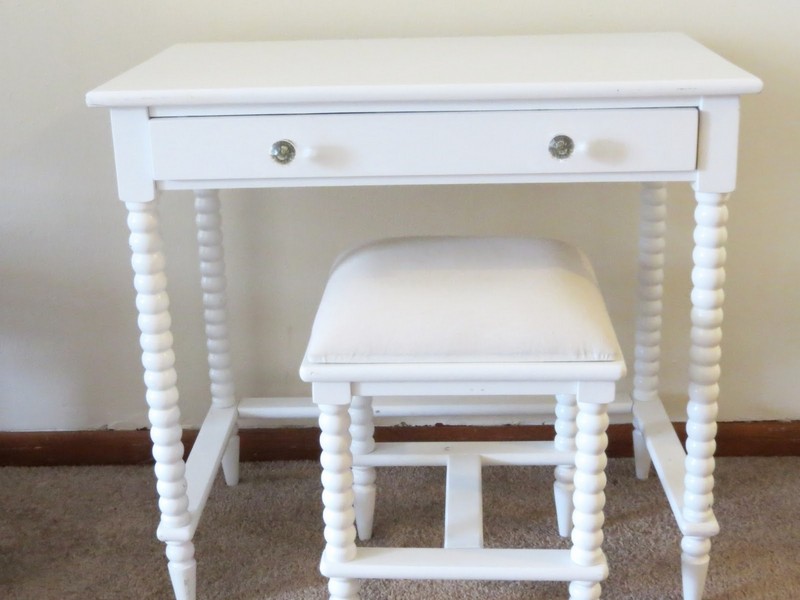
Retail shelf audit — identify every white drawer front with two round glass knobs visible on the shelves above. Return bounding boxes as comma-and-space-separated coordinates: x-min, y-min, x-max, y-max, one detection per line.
150, 108, 698, 183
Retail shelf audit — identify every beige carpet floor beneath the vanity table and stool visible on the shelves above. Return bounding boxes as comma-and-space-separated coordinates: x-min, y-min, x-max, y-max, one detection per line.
0, 458, 800, 600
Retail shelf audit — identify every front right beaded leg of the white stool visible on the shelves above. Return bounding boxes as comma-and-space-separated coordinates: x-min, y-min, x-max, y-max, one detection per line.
569, 394, 613, 600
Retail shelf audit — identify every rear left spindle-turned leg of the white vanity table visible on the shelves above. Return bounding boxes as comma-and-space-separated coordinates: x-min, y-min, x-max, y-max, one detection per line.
195, 190, 239, 485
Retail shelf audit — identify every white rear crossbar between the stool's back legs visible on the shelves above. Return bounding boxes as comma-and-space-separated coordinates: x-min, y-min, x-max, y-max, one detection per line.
353, 441, 574, 467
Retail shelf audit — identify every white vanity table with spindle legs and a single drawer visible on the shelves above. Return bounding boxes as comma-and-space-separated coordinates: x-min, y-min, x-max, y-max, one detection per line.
87, 34, 761, 599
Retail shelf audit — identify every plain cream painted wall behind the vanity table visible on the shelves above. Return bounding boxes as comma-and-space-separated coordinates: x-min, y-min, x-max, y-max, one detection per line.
0, 0, 800, 430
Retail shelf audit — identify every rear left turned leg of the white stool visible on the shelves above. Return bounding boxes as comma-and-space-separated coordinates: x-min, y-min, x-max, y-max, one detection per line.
350, 396, 376, 540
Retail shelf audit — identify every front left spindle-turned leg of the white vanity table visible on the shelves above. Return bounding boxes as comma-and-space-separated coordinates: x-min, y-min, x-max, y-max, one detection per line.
126, 201, 196, 600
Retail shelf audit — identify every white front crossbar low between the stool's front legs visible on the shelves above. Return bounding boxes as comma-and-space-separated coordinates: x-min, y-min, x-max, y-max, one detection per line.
320, 548, 608, 581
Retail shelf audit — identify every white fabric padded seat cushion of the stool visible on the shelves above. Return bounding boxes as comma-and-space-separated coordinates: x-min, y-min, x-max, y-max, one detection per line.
306, 237, 622, 364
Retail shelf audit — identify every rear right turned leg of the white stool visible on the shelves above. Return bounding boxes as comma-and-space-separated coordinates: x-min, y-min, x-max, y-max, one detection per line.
553, 394, 578, 537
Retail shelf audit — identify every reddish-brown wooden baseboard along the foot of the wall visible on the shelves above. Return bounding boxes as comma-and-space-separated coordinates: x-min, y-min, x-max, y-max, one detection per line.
0, 421, 800, 467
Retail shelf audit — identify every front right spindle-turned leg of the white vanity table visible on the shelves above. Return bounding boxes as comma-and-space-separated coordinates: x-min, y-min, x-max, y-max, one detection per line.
681, 192, 728, 600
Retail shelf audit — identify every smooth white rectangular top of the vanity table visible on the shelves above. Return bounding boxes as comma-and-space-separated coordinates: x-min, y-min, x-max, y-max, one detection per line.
86, 33, 762, 108
